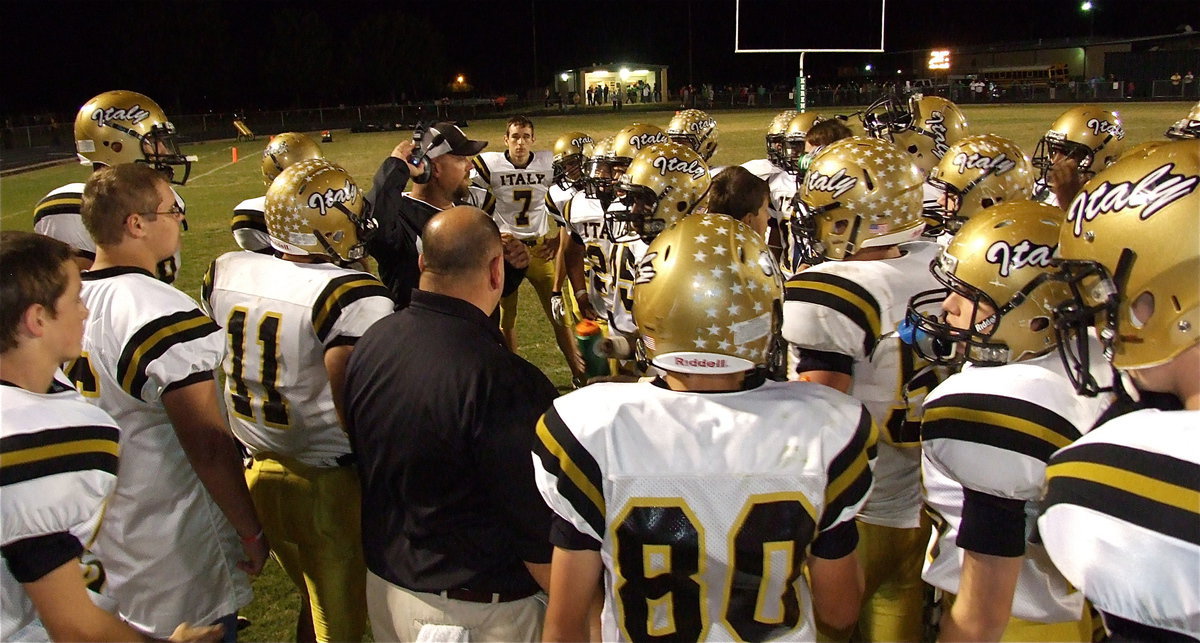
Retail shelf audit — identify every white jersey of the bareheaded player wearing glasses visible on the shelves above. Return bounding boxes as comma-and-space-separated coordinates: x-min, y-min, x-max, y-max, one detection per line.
72, 268, 252, 638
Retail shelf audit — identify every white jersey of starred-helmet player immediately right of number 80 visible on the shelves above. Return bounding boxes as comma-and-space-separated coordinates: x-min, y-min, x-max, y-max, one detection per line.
784, 241, 941, 528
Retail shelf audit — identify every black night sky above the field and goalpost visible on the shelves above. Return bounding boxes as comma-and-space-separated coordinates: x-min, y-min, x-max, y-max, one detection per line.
0, 0, 1200, 114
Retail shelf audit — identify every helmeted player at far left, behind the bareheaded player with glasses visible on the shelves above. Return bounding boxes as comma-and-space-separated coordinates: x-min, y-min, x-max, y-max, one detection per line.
34, 90, 189, 283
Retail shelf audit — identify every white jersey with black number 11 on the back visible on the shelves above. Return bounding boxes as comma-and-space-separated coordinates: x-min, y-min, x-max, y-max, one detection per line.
203, 252, 394, 467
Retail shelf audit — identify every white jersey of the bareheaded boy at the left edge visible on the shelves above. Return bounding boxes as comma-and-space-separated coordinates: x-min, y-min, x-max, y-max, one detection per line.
0, 373, 120, 641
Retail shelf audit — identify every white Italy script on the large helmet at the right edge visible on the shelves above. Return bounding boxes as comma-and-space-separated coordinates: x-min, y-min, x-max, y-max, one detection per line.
1067, 163, 1200, 236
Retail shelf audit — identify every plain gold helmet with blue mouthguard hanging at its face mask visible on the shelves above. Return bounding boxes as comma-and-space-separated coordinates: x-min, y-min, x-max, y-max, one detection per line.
907, 200, 1070, 366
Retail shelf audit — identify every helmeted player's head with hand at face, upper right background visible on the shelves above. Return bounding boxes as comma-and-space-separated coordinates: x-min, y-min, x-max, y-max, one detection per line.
1033, 106, 1126, 208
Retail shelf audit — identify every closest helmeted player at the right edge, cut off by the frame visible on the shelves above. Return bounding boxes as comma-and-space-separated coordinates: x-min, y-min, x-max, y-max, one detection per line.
1038, 139, 1200, 641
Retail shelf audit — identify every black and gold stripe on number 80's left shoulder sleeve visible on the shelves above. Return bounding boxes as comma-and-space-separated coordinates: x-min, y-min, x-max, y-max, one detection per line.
533, 407, 606, 539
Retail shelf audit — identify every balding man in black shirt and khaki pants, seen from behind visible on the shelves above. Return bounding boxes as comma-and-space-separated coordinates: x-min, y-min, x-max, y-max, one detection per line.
346, 206, 557, 642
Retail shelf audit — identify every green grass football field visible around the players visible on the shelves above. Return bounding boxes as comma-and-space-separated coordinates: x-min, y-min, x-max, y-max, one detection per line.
0, 98, 1192, 641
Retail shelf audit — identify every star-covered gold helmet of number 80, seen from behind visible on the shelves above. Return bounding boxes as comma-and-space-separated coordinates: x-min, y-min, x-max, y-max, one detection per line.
634, 214, 784, 374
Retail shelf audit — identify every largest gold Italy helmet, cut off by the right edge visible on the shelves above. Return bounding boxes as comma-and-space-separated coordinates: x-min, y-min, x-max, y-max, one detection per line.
1056, 139, 1200, 395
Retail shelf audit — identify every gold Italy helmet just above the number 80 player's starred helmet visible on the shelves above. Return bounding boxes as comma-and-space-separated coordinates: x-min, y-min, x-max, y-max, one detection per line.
605, 142, 713, 244
